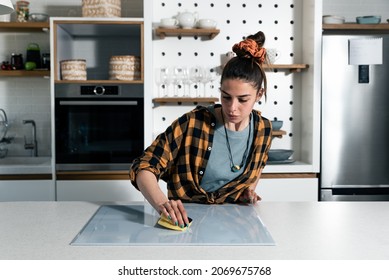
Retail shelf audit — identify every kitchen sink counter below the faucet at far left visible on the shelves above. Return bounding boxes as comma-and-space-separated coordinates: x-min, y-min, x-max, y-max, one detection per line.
0, 157, 51, 174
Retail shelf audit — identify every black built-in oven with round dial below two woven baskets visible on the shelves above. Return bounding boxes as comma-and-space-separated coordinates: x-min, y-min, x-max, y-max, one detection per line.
54, 85, 144, 171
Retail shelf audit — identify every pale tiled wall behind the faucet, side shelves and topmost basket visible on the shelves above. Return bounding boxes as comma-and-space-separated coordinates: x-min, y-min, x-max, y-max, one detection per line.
0, 0, 389, 156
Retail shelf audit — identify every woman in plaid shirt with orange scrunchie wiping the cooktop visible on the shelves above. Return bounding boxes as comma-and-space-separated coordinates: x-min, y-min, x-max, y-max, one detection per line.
130, 32, 271, 227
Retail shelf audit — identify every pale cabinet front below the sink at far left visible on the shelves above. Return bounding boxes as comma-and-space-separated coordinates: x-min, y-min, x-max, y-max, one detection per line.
0, 180, 55, 202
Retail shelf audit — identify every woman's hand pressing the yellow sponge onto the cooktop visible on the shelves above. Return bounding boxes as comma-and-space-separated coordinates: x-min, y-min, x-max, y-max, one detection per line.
158, 200, 189, 228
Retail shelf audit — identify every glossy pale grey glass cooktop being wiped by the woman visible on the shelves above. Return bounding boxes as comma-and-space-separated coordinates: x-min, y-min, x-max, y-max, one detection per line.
71, 204, 275, 246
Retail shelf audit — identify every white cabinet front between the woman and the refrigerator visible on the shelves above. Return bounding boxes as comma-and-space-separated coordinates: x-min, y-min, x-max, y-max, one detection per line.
257, 178, 318, 201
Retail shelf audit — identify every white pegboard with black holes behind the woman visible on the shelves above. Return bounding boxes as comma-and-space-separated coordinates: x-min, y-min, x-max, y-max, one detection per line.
152, 0, 304, 151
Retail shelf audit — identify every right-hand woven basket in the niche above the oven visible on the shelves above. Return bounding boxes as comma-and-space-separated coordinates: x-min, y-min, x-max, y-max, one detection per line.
109, 55, 140, 81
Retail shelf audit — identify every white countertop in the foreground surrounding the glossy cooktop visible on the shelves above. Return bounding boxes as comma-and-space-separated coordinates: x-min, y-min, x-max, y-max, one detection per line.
0, 202, 389, 260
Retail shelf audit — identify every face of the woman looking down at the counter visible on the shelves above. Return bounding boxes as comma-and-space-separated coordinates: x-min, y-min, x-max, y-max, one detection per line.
220, 79, 263, 127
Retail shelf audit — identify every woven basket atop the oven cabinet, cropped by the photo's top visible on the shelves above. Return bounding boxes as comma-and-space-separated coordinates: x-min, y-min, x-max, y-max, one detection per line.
82, 0, 122, 17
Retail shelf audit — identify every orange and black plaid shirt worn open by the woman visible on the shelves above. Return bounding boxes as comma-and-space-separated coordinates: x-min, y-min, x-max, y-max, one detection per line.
130, 104, 272, 203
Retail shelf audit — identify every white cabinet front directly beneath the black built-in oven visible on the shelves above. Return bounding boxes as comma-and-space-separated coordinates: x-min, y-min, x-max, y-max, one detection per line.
56, 180, 144, 202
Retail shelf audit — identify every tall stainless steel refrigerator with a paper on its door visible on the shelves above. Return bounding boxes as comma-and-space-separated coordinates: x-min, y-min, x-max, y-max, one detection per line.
320, 31, 389, 201
